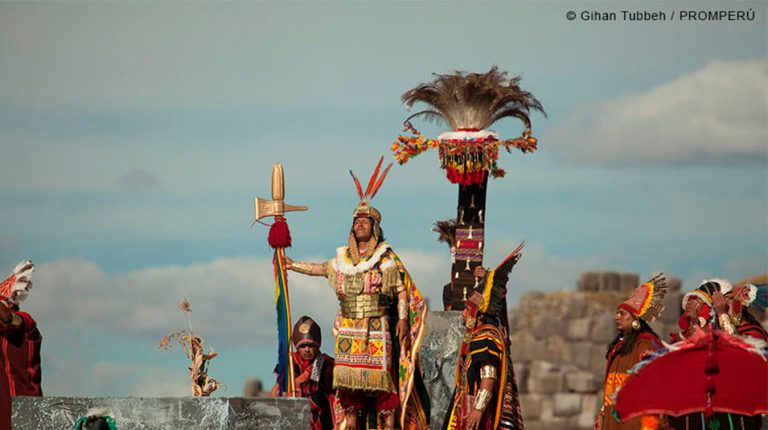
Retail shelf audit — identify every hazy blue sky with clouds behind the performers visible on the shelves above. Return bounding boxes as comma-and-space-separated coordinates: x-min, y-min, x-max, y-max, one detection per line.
0, 1, 768, 397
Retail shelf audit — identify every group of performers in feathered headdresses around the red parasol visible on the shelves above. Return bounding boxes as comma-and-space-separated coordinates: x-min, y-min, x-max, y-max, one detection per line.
595, 276, 768, 430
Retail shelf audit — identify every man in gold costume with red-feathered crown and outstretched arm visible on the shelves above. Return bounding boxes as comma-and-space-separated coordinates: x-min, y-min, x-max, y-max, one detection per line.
286, 157, 429, 429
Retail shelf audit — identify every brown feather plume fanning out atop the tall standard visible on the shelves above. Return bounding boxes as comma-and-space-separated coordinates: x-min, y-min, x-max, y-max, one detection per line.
400, 66, 546, 130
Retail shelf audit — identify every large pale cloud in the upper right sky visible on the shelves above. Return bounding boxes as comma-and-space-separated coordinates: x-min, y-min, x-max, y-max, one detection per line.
547, 61, 768, 165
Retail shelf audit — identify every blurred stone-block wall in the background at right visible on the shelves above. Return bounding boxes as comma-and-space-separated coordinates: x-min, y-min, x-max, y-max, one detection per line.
510, 272, 682, 430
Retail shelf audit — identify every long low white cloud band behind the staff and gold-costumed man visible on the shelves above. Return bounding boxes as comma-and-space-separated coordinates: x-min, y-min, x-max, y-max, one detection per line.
25, 244, 597, 348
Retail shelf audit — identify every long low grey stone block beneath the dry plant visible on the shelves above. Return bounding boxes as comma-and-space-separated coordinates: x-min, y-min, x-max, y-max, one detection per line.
12, 397, 310, 430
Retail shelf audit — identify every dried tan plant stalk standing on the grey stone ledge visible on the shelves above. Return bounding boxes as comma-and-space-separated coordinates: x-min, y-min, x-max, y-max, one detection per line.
158, 299, 221, 397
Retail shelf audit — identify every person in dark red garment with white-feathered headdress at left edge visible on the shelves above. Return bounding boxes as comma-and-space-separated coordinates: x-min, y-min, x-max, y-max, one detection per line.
0, 261, 43, 429
